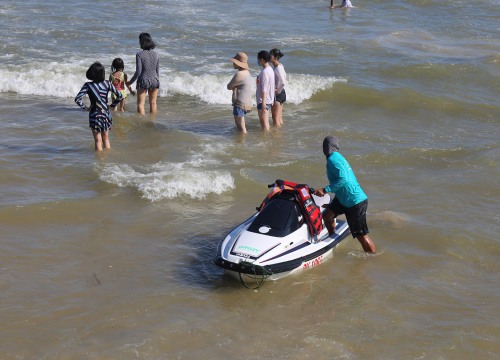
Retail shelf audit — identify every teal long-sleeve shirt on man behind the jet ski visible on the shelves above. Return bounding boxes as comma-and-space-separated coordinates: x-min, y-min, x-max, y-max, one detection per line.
325, 152, 368, 208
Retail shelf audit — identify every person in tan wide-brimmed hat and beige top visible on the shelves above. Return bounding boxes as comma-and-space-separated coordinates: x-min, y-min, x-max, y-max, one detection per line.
227, 51, 252, 134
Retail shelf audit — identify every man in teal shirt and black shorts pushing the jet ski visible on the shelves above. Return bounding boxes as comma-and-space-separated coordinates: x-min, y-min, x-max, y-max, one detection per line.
314, 136, 375, 253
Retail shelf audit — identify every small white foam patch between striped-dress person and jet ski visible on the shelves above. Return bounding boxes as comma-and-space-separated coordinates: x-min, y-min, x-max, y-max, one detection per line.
96, 163, 235, 202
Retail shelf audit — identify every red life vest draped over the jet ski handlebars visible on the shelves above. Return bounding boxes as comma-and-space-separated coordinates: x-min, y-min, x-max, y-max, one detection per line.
257, 180, 323, 236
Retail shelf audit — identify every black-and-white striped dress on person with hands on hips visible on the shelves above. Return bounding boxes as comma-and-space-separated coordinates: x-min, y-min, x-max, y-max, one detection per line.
75, 80, 123, 132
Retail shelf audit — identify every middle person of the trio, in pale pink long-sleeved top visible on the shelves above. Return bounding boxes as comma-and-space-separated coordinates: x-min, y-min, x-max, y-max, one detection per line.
255, 50, 275, 130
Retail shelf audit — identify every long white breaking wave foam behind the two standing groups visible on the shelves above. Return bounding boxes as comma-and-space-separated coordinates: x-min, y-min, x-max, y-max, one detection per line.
0, 60, 346, 105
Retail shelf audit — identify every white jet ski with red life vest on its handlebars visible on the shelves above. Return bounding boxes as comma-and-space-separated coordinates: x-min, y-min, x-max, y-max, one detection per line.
214, 180, 350, 289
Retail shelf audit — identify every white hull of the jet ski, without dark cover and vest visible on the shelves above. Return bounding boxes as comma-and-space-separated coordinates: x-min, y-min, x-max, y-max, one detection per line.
214, 196, 350, 284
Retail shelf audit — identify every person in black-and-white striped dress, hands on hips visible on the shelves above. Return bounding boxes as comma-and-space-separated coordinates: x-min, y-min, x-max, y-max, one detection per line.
75, 62, 123, 151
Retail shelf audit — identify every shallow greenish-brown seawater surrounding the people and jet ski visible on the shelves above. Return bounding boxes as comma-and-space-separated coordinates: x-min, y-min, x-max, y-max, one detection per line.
0, 0, 500, 359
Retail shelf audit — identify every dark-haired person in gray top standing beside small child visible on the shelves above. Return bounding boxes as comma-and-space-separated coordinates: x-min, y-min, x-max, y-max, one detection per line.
127, 33, 160, 115
